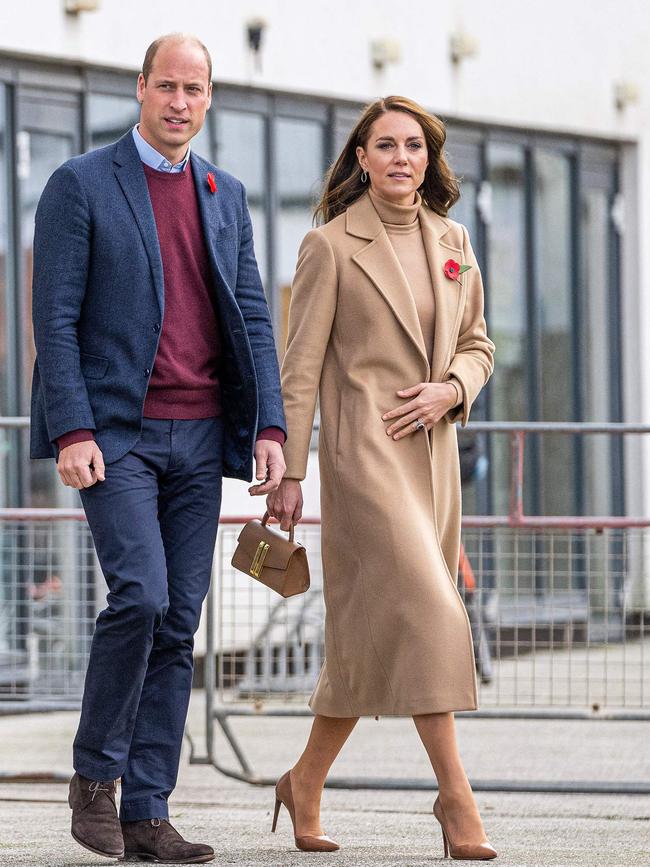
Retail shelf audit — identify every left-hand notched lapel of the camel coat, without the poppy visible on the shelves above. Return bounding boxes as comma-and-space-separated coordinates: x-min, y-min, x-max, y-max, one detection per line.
346, 195, 429, 379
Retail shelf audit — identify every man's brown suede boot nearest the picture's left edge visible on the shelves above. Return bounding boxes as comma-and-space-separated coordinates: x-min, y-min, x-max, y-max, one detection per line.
68, 774, 124, 858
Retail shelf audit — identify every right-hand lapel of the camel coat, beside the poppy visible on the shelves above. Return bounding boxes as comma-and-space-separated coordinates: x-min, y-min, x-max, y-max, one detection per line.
420, 207, 467, 382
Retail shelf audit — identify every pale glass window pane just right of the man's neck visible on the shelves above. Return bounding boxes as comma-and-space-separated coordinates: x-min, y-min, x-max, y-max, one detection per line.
217, 109, 269, 282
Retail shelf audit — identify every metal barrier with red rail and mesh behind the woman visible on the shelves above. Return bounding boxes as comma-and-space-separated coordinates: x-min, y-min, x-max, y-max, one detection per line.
193, 423, 650, 792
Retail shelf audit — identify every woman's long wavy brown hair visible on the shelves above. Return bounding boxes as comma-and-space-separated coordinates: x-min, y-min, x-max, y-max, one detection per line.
314, 96, 460, 223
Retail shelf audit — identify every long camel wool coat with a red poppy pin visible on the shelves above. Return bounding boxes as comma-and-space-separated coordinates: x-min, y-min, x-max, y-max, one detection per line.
282, 194, 494, 717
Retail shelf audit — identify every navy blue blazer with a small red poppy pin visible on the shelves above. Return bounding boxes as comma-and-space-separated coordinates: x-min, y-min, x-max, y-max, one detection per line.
31, 131, 286, 480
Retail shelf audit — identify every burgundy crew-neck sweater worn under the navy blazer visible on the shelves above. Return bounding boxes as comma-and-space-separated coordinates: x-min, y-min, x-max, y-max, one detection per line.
57, 164, 285, 449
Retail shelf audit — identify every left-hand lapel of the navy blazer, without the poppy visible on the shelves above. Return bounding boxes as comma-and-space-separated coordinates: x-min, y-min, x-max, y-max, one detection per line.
113, 131, 164, 321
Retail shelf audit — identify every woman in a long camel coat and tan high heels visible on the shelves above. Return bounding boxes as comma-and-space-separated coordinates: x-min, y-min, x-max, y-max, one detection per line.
267, 97, 496, 859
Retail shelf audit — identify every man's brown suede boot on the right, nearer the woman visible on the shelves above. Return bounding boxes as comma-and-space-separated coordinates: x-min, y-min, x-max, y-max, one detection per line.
122, 819, 214, 864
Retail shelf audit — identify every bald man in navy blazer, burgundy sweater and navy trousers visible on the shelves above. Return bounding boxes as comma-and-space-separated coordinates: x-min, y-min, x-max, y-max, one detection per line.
32, 34, 285, 863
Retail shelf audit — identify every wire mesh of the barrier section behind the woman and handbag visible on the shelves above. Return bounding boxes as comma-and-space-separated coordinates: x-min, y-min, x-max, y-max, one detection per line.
208, 524, 650, 710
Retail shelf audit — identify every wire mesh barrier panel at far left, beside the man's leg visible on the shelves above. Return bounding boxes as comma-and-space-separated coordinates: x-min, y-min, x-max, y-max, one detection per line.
0, 513, 98, 711
